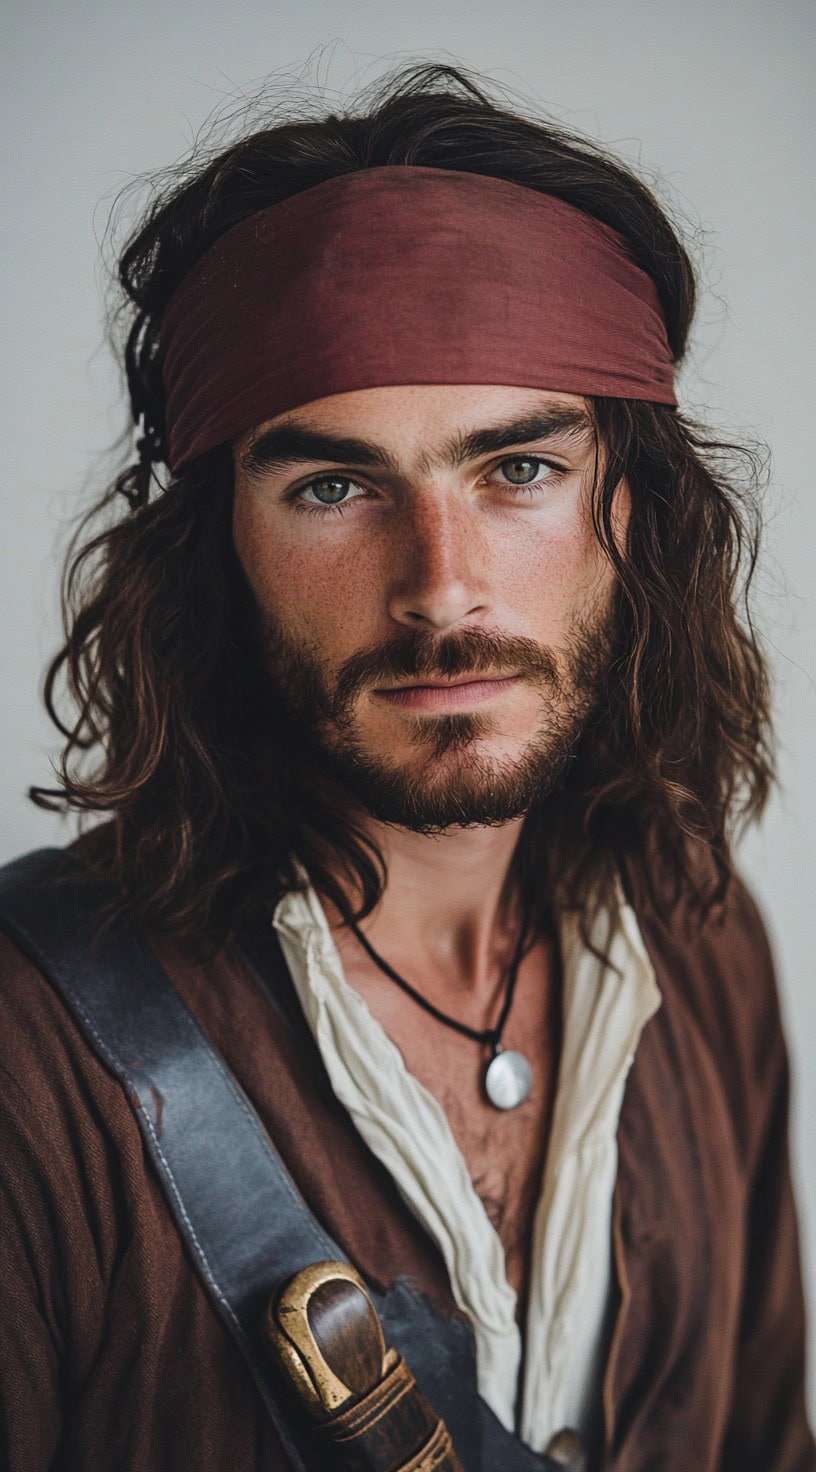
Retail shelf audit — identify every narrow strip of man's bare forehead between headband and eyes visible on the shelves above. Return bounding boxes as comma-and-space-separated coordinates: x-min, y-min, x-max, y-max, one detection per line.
236, 384, 594, 473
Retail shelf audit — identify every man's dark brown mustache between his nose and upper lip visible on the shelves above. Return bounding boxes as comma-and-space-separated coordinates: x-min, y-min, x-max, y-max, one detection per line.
333, 629, 561, 718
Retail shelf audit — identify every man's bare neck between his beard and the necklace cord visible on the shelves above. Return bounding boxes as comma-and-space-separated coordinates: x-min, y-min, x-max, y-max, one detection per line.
310, 818, 523, 995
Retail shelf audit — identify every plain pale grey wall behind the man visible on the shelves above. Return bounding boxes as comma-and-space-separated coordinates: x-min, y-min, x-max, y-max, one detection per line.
0, 0, 816, 1406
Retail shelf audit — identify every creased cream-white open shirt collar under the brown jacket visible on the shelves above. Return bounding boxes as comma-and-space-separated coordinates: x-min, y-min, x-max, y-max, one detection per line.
272, 879, 660, 1451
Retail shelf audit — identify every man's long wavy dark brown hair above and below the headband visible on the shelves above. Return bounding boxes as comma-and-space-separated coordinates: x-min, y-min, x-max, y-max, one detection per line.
29, 63, 773, 945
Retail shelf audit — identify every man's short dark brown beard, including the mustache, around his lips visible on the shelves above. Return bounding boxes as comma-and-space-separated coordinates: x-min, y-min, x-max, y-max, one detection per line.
261, 604, 616, 835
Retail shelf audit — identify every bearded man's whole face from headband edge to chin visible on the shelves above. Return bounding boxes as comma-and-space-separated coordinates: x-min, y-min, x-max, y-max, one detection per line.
234, 384, 629, 832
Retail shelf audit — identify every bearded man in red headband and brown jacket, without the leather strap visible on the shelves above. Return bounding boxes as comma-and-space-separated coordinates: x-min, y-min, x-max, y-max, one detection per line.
0, 68, 816, 1472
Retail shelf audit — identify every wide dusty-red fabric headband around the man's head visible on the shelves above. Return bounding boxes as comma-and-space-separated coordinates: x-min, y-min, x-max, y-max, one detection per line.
161, 165, 678, 470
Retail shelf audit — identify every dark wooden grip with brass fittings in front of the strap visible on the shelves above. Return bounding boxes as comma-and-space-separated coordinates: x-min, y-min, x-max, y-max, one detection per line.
265, 1263, 462, 1472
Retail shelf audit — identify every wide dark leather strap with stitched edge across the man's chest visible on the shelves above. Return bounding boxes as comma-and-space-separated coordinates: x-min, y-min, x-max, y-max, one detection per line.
0, 848, 558, 1472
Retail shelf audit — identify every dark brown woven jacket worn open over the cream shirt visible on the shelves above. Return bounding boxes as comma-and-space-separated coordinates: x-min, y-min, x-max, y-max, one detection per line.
0, 859, 816, 1472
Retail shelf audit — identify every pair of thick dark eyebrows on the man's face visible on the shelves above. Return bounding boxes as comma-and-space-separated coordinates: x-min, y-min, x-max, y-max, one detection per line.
240, 405, 594, 475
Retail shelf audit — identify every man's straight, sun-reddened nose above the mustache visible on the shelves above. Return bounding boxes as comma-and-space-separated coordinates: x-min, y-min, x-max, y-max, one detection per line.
389, 487, 489, 631
